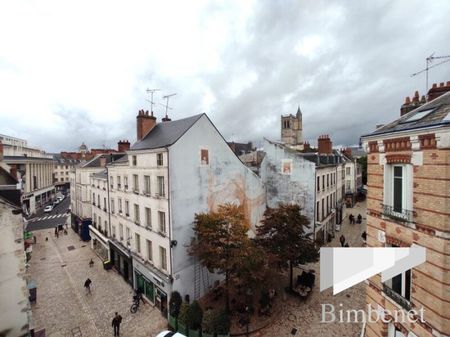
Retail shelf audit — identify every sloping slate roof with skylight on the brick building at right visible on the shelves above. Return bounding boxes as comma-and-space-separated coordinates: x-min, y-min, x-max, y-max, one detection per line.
362, 92, 450, 137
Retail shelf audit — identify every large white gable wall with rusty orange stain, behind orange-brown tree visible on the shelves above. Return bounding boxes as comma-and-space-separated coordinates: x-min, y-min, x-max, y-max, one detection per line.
168, 115, 266, 298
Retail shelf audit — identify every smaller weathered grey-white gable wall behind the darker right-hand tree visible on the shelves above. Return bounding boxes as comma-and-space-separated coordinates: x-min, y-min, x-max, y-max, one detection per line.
261, 140, 316, 227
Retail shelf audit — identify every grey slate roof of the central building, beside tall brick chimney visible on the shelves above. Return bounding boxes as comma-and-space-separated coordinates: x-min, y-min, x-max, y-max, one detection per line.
130, 114, 204, 150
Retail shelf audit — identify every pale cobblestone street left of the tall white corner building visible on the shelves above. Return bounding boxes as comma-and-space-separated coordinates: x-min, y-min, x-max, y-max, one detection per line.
30, 229, 167, 337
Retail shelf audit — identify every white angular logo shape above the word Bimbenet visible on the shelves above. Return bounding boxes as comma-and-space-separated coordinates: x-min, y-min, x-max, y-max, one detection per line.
320, 244, 426, 295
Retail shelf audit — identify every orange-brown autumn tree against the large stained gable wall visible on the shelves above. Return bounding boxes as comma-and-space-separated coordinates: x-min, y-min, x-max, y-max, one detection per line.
188, 204, 249, 310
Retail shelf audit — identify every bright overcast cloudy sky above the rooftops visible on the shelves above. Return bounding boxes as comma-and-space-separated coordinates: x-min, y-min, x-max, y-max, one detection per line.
0, 0, 450, 152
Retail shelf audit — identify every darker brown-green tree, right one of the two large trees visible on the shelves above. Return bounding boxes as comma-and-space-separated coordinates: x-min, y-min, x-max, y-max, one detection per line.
256, 204, 319, 288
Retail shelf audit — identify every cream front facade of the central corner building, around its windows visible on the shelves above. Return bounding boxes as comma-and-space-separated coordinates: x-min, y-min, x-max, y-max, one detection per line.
108, 153, 171, 275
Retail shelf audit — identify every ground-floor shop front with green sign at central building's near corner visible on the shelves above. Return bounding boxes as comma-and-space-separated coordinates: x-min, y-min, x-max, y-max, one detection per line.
133, 254, 172, 316
